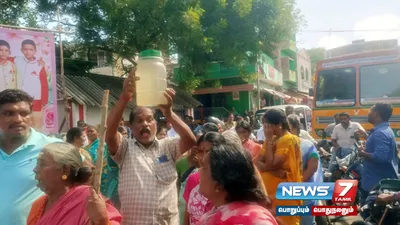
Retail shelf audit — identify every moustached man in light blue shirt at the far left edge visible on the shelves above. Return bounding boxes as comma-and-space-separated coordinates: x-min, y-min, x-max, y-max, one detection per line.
0, 89, 60, 225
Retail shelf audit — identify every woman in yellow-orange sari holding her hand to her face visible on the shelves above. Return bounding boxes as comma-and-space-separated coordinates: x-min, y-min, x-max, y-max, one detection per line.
258, 109, 302, 225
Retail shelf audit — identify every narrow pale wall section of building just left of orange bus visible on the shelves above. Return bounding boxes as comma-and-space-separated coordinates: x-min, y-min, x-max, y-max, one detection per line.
297, 49, 312, 93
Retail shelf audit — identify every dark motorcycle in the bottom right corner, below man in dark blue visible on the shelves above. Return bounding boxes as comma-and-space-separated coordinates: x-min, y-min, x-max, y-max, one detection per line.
352, 179, 400, 225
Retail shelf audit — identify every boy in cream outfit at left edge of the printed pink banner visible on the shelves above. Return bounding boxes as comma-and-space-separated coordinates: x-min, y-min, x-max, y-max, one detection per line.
0, 40, 17, 91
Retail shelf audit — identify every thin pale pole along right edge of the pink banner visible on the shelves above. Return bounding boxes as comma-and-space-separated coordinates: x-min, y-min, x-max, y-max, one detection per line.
57, 6, 71, 132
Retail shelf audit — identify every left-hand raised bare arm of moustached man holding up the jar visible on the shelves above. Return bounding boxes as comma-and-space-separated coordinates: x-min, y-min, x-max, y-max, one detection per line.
106, 70, 138, 155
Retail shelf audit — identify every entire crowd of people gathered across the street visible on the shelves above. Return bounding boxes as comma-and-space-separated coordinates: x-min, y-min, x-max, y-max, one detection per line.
0, 67, 398, 225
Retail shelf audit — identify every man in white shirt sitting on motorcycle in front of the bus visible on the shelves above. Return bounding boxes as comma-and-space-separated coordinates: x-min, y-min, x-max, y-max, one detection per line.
328, 113, 364, 172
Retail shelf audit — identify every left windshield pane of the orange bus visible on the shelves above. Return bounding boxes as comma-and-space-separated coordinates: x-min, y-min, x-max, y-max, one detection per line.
316, 67, 356, 107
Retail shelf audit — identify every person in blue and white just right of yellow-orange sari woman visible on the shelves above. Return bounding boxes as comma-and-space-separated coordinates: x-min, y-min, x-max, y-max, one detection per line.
287, 114, 323, 225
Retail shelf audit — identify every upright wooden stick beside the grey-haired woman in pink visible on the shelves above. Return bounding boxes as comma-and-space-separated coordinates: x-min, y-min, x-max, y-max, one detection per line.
93, 90, 110, 193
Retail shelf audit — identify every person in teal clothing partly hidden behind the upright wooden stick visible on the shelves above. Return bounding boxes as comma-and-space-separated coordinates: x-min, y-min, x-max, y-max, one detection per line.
85, 125, 120, 209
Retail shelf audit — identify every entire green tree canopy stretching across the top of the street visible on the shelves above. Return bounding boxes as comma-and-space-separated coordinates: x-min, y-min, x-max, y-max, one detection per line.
0, 0, 301, 91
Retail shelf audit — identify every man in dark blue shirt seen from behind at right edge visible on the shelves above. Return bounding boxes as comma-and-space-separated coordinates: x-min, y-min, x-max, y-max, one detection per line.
358, 103, 399, 219
